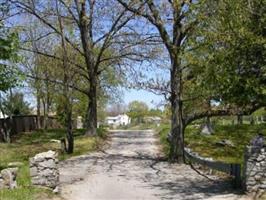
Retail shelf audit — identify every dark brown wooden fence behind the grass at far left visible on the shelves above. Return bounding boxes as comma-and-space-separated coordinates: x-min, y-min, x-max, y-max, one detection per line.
0, 115, 61, 140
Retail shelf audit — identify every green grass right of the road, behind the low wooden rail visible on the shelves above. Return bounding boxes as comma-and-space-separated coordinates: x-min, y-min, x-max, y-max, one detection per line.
159, 124, 266, 163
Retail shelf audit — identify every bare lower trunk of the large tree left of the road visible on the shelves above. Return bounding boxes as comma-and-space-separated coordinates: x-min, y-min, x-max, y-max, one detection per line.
85, 82, 97, 136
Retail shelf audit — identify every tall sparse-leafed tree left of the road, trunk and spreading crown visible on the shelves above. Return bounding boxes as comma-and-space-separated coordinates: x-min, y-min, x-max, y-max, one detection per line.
11, 0, 152, 135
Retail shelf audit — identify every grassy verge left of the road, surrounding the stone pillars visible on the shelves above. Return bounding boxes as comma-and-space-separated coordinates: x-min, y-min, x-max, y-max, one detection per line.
0, 129, 106, 200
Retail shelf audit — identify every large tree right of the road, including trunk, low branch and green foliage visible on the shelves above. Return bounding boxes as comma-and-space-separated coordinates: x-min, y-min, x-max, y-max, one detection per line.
118, 0, 266, 163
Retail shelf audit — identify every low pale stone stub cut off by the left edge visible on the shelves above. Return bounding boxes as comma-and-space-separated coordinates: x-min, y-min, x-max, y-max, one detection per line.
0, 168, 18, 189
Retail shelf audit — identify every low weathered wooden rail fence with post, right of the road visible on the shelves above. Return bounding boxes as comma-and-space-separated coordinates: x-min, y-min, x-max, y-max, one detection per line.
185, 149, 242, 188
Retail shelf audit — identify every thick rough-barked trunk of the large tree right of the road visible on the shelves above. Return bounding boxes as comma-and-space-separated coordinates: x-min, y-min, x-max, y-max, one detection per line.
169, 54, 185, 163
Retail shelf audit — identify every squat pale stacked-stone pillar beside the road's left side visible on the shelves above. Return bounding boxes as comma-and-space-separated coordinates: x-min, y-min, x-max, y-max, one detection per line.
30, 151, 59, 189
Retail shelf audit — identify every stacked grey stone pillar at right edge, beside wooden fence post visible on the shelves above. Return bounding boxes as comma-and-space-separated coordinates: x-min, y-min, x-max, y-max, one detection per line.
243, 146, 266, 193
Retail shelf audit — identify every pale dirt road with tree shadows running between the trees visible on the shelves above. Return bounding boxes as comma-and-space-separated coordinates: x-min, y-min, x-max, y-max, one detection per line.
56, 131, 247, 200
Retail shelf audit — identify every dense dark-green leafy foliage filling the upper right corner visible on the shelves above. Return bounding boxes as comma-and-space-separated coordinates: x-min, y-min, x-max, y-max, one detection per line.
194, 0, 266, 110
